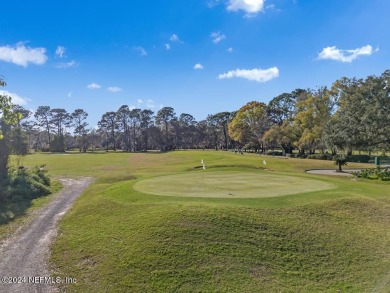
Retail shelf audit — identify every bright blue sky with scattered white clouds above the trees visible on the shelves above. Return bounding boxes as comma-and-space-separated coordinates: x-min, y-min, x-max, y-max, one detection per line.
0, 0, 390, 126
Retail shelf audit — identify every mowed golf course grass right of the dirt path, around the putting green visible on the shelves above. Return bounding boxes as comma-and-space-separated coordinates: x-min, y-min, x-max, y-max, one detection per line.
24, 151, 390, 292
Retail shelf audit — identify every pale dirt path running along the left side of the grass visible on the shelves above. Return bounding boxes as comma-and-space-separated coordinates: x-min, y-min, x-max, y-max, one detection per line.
0, 178, 92, 293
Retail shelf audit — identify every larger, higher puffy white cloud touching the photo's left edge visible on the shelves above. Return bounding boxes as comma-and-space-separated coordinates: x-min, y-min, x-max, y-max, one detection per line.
0, 42, 47, 67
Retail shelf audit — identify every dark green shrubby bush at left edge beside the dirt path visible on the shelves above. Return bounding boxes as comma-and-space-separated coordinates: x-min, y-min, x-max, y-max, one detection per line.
0, 165, 52, 224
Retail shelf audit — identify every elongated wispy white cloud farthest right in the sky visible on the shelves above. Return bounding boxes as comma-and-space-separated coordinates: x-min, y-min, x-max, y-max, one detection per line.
318, 45, 379, 63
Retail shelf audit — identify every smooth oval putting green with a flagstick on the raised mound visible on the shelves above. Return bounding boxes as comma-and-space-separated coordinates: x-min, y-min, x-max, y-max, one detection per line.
133, 171, 335, 198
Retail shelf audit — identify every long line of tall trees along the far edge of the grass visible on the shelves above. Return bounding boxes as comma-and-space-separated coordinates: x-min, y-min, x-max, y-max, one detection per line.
0, 70, 390, 176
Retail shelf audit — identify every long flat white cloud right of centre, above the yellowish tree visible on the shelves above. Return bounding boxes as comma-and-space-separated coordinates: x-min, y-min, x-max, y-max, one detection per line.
218, 67, 279, 82
